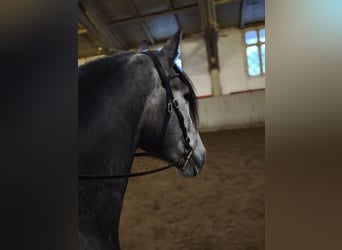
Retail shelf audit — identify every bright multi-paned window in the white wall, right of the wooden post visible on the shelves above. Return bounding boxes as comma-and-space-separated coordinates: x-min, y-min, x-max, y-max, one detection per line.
245, 28, 266, 76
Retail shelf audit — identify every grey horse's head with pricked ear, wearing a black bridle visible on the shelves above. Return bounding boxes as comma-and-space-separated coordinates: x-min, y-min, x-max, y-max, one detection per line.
138, 31, 206, 176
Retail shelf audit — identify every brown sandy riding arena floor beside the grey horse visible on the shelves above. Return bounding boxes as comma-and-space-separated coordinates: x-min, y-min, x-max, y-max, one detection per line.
120, 128, 265, 250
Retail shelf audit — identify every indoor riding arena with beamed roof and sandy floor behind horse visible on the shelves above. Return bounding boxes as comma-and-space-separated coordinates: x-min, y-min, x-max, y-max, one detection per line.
78, 0, 265, 250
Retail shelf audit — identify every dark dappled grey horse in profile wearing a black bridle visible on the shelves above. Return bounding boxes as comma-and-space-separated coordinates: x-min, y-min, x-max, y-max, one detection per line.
78, 31, 206, 250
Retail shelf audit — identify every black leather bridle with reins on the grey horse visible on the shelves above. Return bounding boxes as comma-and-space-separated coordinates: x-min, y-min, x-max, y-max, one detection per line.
78, 51, 195, 180
